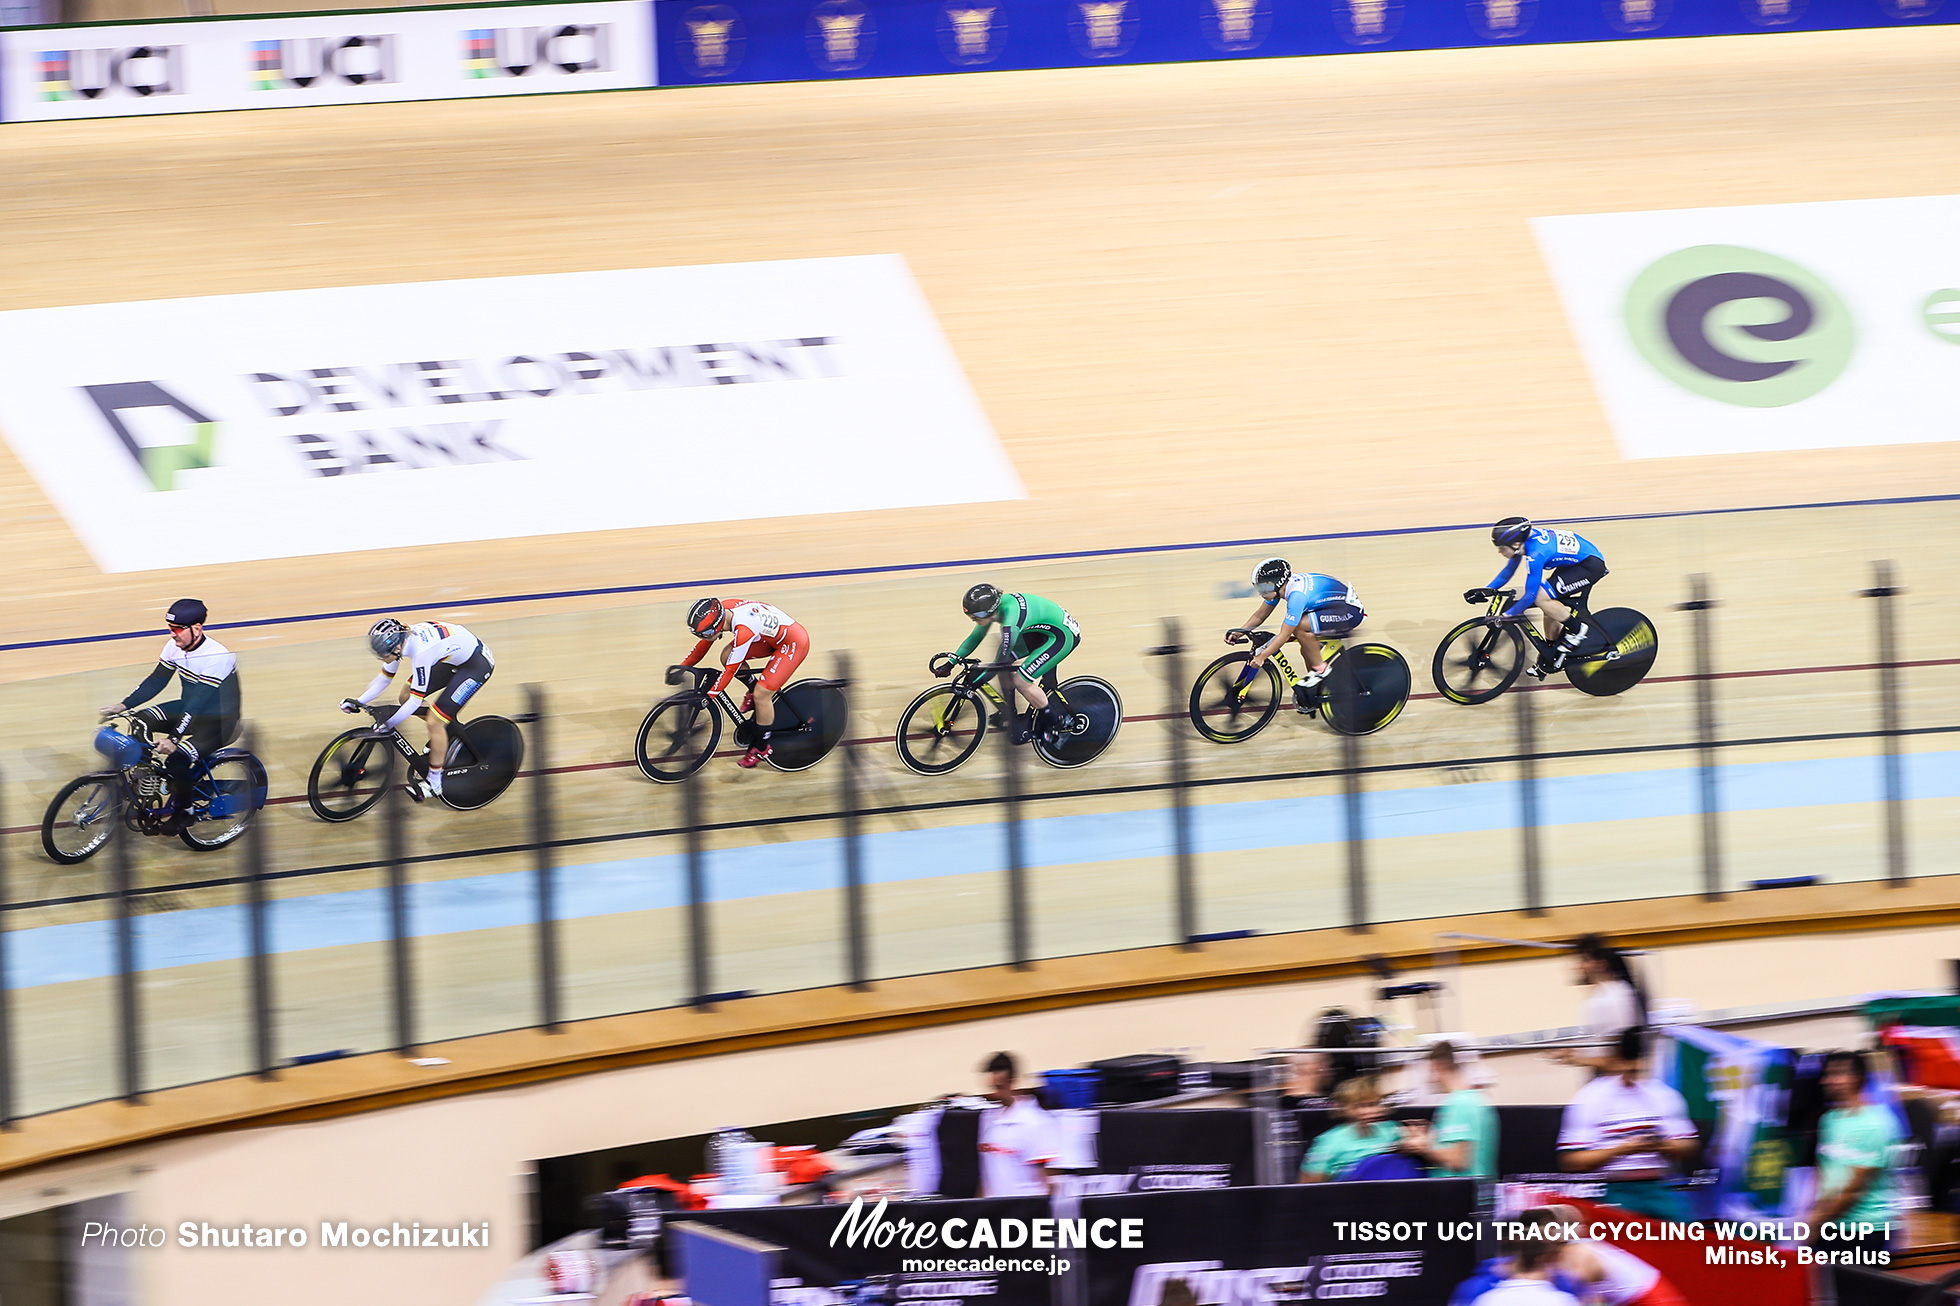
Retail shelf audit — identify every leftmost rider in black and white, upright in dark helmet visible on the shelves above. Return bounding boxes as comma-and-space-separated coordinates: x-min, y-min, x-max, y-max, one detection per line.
102, 598, 239, 833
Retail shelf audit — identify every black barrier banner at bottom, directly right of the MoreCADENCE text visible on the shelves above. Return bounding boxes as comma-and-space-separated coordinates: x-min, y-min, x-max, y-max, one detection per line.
1082, 1179, 1476, 1306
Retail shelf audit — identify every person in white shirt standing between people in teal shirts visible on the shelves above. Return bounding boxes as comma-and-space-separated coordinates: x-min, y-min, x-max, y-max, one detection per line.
1558, 1026, 1701, 1220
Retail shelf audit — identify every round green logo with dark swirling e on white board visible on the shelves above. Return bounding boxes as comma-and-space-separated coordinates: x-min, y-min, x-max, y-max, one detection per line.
1625, 245, 1856, 408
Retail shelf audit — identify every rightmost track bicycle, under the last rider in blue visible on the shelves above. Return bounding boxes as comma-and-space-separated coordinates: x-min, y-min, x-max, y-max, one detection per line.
1429, 590, 1660, 706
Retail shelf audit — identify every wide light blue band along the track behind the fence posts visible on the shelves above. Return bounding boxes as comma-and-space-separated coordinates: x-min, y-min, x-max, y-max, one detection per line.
8, 751, 1960, 988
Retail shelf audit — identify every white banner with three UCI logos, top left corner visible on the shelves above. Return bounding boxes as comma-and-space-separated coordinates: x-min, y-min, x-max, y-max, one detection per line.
0, 0, 655, 122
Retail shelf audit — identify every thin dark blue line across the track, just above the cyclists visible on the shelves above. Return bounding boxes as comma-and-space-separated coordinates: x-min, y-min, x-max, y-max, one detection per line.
0, 494, 1960, 653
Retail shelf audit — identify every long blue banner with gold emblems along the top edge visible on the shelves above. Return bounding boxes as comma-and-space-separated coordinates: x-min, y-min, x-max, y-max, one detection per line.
655, 0, 1960, 84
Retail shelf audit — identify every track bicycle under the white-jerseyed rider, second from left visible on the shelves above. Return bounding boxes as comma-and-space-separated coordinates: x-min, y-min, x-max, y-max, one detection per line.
306, 704, 523, 822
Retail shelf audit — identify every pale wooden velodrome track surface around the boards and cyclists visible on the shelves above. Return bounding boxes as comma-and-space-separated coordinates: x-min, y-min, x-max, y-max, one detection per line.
0, 27, 1960, 1110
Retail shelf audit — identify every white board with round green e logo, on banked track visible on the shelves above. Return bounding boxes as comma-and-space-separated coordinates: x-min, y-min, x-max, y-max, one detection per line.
1533, 196, 1960, 459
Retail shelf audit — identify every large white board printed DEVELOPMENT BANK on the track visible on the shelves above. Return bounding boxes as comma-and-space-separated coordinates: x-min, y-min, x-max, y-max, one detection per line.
0, 255, 1023, 571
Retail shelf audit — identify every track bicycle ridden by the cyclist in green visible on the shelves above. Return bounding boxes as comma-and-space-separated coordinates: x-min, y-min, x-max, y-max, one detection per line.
894, 653, 1123, 775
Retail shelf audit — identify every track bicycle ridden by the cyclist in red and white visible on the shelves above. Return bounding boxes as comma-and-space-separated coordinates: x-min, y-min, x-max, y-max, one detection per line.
633, 667, 851, 784
